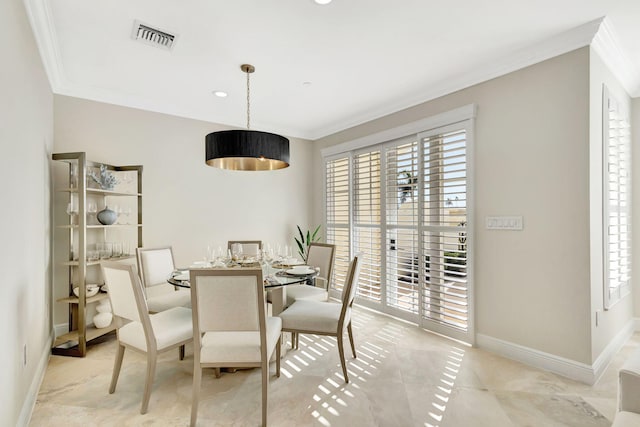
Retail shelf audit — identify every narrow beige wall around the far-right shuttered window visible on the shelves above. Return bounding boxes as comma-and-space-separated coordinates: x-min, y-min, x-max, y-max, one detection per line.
589, 49, 633, 360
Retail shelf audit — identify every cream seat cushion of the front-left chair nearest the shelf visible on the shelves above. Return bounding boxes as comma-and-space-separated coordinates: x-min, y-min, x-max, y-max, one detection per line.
118, 307, 193, 351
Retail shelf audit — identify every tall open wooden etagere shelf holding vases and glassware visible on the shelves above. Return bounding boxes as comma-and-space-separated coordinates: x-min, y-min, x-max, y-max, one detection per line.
51, 152, 142, 357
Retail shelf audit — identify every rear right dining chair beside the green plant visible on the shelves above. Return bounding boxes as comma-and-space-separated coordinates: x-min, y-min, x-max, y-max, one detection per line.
286, 243, 336, 306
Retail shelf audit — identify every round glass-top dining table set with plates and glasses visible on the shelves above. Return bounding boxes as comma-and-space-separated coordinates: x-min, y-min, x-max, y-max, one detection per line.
167, 261, 319, 316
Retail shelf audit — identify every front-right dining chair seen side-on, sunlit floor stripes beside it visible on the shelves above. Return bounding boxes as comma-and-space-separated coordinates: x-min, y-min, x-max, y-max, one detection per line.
279, 254, 362, 383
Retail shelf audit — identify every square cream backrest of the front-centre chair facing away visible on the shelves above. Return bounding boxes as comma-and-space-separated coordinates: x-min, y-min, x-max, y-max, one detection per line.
190, 268, 266, 336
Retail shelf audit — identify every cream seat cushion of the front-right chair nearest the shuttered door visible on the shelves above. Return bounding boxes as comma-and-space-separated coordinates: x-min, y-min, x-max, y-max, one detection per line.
279, 300, 344, 334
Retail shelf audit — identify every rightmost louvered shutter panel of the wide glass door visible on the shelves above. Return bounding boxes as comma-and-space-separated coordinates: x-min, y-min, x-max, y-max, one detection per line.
421, 129, 469, 331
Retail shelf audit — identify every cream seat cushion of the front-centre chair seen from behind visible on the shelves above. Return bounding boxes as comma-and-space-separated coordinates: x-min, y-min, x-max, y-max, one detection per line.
200, 317, 282, 363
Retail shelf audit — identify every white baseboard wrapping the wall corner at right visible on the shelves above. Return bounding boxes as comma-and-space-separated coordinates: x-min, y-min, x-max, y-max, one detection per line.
476, 319, 640, 385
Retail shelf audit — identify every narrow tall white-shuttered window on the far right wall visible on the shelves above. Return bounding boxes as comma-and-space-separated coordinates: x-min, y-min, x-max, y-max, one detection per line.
602, 87, 631, 308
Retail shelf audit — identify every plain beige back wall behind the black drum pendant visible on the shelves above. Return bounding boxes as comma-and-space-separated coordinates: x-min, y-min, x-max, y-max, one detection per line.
54, 96, 312, 324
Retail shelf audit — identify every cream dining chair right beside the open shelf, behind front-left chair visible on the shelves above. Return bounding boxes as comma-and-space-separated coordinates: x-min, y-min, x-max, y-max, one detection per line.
136, 246, 191, 313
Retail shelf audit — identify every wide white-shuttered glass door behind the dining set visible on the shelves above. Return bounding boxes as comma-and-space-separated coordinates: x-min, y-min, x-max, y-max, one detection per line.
323, 107, 473, 342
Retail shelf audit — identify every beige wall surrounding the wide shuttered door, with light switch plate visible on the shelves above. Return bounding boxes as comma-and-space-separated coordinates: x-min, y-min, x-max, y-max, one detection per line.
313, 48, 592, 364
